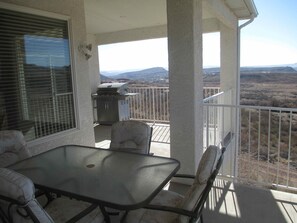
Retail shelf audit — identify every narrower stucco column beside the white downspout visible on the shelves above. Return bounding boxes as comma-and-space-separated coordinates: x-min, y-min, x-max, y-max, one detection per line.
220, 24, 239, 176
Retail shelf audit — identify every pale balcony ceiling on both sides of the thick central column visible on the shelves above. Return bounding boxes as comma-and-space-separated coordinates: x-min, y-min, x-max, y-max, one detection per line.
85, 0, 257, 34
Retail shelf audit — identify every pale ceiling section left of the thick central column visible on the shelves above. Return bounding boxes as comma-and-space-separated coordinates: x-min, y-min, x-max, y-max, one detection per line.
85, 0, 167, 34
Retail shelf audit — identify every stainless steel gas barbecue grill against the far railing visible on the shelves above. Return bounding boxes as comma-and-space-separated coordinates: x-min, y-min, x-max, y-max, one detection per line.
93, 83, 135, 125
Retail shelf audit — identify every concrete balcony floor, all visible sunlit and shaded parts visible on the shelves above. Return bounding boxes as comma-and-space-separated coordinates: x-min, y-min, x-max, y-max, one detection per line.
94, 125, 297, 223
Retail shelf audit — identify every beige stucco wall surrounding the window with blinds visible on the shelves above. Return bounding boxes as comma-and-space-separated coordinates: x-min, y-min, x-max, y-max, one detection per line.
0, 0, 95, 155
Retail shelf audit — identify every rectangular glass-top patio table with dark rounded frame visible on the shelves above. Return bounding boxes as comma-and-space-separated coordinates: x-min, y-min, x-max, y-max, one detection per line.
9, 145, 180, 221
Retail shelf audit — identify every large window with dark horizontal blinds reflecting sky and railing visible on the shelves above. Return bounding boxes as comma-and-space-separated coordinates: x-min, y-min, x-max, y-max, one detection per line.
0, 9, 75, 141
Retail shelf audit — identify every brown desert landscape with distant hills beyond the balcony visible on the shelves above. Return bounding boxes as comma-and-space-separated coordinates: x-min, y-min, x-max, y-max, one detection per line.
103, 66, 297, 189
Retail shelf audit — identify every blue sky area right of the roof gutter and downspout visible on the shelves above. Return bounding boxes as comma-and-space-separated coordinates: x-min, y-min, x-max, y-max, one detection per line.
241, 0, 297, 66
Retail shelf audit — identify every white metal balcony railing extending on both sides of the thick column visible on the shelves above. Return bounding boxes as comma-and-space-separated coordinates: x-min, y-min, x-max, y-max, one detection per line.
92, 87, 297, 189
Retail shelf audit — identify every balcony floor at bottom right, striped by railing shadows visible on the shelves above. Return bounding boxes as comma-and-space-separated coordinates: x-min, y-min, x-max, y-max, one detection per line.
204, 180, 297, 223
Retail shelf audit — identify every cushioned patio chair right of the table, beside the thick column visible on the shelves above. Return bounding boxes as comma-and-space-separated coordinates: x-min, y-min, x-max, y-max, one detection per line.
122, 146, 225, 223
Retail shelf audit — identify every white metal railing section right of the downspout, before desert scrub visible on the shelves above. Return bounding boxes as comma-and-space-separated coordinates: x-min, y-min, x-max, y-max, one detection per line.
238, 106, 297, 188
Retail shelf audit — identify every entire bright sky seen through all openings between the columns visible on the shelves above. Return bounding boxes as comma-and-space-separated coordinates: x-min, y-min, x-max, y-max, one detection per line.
99, 0, 297, 72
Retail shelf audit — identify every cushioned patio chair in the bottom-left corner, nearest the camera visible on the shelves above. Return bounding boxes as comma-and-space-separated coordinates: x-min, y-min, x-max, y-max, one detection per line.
0, 168, 104, 223
